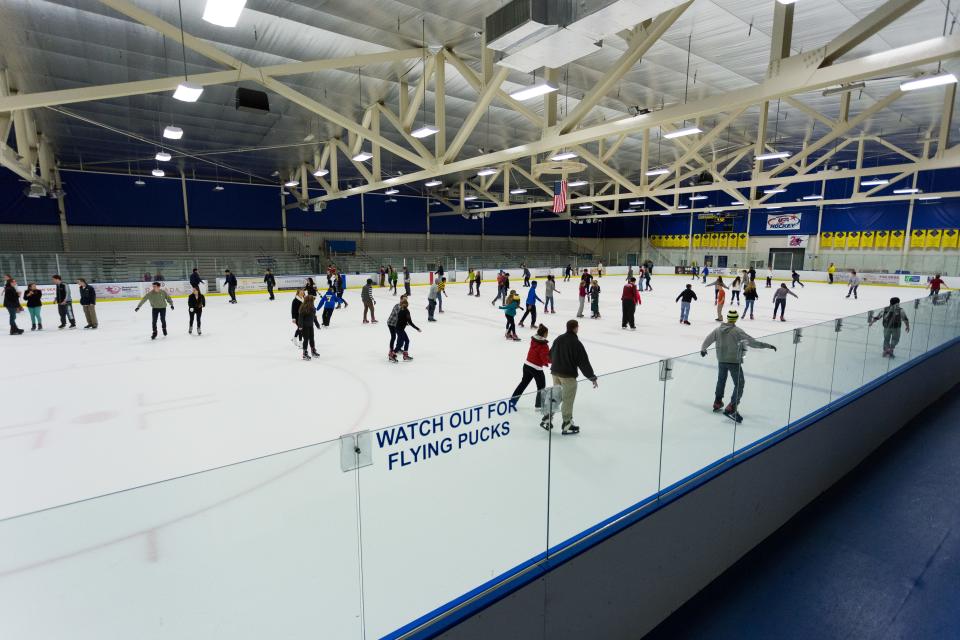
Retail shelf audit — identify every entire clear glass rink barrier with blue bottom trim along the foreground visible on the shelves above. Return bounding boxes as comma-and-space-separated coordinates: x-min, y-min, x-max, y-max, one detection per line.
0, 295, 960, 639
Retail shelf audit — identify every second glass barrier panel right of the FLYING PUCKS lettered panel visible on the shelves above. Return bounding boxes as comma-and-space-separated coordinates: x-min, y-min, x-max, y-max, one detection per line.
660, 347, 736, 491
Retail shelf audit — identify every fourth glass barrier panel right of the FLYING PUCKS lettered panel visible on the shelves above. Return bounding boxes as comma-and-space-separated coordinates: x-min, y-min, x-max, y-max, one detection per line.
790, 320, 837, 422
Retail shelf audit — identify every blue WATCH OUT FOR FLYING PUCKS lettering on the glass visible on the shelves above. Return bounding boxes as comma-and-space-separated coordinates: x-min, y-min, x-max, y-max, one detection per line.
373, 400, 517, 471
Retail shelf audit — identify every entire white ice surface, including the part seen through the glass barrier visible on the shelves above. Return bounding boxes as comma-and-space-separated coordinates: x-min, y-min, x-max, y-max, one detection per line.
0, 276, 932, 640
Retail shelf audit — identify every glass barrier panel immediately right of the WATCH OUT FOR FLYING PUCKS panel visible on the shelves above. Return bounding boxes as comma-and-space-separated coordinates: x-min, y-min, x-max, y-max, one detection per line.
549, 363, 663, 548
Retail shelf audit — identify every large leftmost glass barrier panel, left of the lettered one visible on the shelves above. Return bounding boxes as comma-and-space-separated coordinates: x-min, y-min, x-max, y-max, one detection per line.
0, 441, 361, 640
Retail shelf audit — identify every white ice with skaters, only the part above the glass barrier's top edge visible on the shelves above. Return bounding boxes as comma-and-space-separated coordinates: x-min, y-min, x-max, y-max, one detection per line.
0, 275, 925, 517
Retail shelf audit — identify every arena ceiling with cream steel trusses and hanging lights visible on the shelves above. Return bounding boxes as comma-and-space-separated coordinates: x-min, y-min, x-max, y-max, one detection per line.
0, 0, 960, 218
